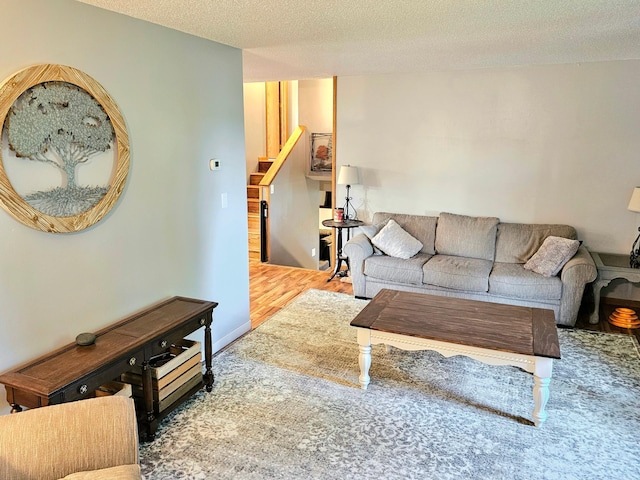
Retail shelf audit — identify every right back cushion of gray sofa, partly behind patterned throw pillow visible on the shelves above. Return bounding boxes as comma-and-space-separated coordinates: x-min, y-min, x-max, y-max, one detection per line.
496, 223, 577, 263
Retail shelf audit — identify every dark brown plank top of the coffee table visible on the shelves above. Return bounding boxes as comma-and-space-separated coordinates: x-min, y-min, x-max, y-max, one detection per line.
351, 289, 560, 358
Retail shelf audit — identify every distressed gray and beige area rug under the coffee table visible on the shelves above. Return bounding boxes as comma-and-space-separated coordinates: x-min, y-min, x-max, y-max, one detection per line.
140, 290, 640, 480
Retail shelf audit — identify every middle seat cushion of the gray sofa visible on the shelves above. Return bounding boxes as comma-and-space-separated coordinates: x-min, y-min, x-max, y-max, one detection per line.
422, 255, 493, 292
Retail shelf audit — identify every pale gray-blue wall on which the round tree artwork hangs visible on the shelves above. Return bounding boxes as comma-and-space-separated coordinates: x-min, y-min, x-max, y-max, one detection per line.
0, 0, 250, 413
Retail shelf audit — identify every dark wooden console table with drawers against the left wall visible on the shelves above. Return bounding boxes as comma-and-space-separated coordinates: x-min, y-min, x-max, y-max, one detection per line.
0, 297, 218, 440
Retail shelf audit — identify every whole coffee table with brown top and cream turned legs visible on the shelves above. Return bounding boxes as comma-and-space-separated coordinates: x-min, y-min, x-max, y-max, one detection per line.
351, 290, 560, 427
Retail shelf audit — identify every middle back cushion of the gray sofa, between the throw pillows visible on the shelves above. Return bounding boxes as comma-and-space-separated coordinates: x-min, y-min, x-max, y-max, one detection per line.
436, 213, 500, 261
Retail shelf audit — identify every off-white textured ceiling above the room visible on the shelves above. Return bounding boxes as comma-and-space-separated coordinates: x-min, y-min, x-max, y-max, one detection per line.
78, 0, 640, 81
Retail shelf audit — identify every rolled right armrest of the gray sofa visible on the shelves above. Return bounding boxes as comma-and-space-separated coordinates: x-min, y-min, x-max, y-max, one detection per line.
556, 246, 598, 327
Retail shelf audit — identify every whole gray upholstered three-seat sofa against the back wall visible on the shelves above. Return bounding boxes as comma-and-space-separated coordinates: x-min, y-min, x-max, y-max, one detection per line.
343, 212, 596, 326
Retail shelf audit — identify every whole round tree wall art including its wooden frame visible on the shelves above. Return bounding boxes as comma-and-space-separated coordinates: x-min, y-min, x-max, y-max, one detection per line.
0, 65, 129, 232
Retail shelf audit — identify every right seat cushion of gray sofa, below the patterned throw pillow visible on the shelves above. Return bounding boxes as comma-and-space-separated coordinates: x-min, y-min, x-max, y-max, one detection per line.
489, 262, 562, 300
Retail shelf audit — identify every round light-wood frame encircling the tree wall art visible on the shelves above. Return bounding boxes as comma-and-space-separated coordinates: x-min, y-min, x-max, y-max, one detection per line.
0, 64, 129, 233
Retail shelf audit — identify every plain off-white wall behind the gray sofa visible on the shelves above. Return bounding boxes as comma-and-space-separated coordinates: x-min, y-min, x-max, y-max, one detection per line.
336, 61, 640, 296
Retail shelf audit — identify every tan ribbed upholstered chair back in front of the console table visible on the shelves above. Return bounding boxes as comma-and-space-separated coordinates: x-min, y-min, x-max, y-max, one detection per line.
0, 396, 139, 480
